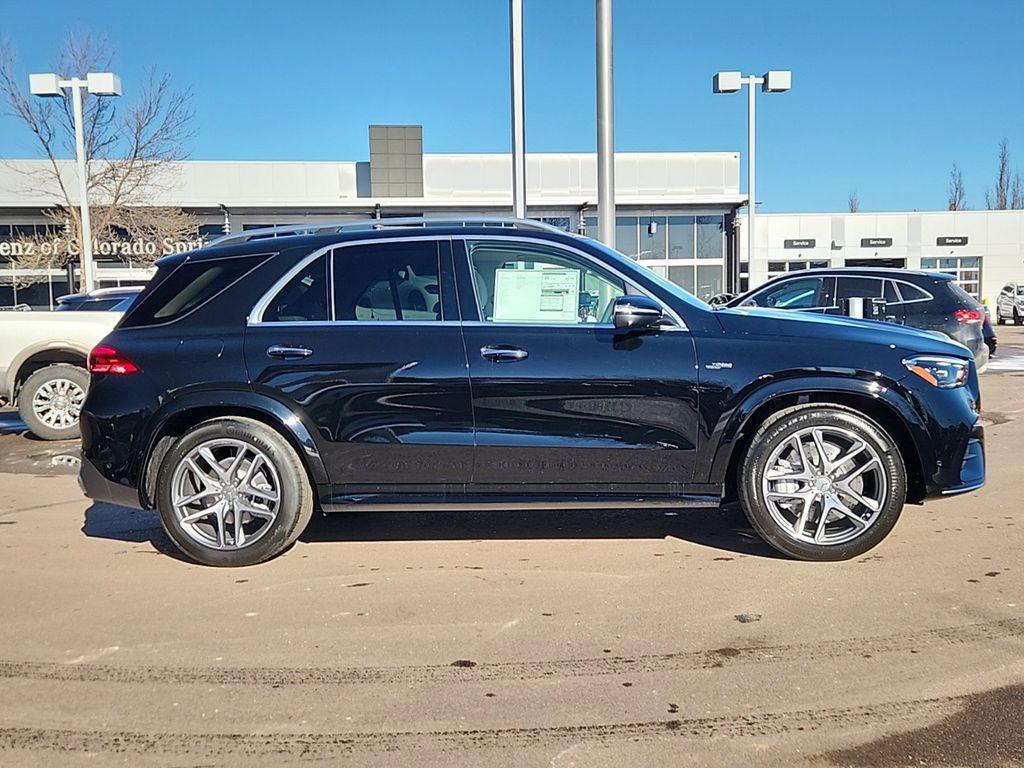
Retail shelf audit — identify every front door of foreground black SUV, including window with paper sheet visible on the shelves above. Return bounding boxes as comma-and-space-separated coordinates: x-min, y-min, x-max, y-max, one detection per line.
455, 240, 697, 496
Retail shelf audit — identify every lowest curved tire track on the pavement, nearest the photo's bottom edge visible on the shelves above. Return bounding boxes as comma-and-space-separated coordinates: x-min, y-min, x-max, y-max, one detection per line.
0, 696, 968, 760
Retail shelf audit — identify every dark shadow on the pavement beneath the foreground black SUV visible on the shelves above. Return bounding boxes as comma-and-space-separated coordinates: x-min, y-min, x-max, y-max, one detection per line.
82, 502, 780, 560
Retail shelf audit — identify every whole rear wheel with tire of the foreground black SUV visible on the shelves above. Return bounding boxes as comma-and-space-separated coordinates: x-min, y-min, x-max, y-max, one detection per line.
156, 417, 313, 566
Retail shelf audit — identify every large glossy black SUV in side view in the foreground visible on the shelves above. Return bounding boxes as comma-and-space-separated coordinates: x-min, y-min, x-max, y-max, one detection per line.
81, 220, 985, 565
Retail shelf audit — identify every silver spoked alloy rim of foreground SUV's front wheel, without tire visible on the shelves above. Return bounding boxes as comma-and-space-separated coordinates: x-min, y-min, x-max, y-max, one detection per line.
761, 427, 889, 546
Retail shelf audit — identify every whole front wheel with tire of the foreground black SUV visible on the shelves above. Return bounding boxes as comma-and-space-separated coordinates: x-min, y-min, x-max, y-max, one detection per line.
738, 404, 906, 560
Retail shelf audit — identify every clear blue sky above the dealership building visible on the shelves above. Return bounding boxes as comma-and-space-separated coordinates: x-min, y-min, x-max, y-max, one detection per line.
0, 0, 1024, 211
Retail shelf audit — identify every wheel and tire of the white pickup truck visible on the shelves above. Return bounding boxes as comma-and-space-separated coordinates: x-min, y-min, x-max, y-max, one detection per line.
17, 362, 89, 440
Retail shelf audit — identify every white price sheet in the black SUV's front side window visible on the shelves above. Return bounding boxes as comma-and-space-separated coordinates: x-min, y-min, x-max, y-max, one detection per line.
494, 268, 580, 325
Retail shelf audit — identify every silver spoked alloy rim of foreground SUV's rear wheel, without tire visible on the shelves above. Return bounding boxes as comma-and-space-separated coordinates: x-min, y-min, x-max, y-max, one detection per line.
171, 438, 281, 550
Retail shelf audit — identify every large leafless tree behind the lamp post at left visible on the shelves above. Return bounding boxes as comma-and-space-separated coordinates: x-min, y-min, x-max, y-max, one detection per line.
0, 35, 197, 284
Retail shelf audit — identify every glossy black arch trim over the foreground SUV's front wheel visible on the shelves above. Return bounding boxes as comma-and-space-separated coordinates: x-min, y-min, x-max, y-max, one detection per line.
711, 380, 928, 503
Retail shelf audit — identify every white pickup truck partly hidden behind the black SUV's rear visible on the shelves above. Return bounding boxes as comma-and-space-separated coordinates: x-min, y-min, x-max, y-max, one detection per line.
0, 311, 123, 440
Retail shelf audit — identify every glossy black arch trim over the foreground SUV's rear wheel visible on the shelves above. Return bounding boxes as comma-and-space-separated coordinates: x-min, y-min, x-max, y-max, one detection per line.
139, 392, 328, 508
